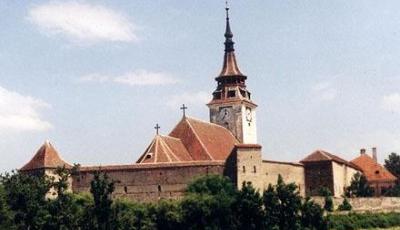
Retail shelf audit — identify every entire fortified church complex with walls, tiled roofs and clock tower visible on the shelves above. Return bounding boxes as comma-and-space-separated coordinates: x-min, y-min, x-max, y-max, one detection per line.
20, 8, 396, 201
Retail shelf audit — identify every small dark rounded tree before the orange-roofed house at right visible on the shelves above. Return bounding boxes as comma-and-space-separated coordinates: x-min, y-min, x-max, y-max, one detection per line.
346, 172, 374, 197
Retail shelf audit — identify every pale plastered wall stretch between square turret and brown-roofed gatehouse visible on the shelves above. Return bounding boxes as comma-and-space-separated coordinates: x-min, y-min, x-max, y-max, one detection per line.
261, 160, 305, 196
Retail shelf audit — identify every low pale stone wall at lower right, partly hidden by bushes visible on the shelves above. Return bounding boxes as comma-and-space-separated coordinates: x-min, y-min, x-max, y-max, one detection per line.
312, 197, 400, 212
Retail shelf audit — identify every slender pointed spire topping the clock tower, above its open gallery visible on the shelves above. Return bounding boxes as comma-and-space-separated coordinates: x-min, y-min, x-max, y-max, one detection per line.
218, 4, 244, 77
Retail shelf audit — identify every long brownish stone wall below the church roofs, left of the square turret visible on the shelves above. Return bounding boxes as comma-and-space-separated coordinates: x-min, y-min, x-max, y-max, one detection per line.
72, 161, 225, 202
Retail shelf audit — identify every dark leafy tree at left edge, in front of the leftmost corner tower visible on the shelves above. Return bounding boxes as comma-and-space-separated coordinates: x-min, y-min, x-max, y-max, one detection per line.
0, 172, 51, 229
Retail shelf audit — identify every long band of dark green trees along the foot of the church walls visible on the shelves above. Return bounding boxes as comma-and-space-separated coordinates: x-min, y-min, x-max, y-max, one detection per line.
0, 172, 327, 230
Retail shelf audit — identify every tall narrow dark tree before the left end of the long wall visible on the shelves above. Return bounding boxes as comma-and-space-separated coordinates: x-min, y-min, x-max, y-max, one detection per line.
90, 171, 115, 230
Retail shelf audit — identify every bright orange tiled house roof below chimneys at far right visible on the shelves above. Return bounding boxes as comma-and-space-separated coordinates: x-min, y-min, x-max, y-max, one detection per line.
351, 154, 397, 182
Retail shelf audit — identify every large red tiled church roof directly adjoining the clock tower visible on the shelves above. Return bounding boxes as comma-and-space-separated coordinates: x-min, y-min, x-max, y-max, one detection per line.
169, 117, 238, 160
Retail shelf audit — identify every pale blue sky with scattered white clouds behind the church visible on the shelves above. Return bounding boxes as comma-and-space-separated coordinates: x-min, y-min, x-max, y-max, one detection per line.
0, 0, 400, 171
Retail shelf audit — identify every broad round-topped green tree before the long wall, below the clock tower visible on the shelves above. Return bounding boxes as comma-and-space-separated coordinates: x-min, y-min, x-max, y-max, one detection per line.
181, 175, 237, 229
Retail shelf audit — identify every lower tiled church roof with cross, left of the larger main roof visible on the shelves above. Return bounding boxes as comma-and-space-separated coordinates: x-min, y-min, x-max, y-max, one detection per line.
136, 135, 192, 163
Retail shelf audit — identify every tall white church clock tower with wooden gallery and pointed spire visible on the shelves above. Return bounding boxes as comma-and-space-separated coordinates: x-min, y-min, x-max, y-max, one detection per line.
207, 7, 257, 144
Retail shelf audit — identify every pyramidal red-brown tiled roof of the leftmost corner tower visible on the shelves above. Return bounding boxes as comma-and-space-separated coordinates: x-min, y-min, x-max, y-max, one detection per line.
20, 141, 72, 171
